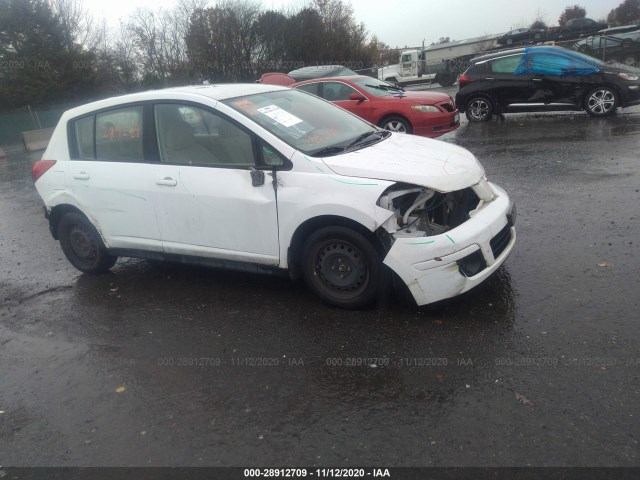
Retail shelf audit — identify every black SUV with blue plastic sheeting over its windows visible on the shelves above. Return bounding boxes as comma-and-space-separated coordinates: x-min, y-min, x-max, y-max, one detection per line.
456, 46, 640, 122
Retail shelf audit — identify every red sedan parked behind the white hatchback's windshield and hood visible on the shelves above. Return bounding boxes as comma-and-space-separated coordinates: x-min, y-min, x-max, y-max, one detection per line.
291, 75, 460, 138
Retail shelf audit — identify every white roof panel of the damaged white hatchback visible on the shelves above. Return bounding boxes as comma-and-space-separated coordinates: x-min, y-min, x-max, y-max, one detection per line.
66, 83, 287, 116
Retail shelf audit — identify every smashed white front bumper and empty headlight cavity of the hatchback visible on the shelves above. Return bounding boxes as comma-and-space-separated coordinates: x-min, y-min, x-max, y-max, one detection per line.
378, 177, 515, 305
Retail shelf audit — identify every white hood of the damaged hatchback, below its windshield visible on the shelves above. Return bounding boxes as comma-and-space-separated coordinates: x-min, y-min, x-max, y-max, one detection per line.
322, 133, 484, 192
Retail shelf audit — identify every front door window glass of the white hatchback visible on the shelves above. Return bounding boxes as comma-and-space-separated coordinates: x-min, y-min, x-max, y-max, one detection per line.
154, 103, 256, 168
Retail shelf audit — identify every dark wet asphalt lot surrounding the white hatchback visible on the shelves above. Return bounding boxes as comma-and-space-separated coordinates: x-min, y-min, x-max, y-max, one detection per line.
0, 101, 640, 467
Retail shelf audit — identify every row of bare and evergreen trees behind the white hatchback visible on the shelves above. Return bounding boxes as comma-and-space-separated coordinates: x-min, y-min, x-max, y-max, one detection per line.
0, 0, 385, 110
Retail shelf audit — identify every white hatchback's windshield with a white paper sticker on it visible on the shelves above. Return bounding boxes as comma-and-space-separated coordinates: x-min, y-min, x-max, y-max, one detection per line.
224, 90, 382, 156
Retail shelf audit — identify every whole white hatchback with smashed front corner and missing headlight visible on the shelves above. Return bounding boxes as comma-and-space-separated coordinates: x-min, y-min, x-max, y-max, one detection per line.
32, 84, 516, 308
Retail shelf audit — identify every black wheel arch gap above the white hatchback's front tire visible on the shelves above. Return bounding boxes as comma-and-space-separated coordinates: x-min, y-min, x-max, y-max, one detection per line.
287, 215, 384, 279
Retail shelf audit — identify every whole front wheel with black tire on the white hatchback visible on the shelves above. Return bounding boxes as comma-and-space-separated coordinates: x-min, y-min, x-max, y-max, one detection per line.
302, 227, 384, 309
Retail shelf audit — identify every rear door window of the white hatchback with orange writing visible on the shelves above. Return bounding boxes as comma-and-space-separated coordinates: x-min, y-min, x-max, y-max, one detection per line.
71, 106, 144, 161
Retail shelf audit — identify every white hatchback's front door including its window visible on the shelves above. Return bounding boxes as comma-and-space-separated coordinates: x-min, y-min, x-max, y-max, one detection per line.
152, 103, 279, 265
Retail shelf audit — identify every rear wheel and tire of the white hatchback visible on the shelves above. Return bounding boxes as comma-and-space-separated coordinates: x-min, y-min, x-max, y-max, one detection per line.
58, 212, 118, 273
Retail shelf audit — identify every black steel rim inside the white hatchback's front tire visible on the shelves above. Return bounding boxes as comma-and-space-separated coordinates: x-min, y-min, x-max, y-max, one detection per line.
315, 240, 369, 296
